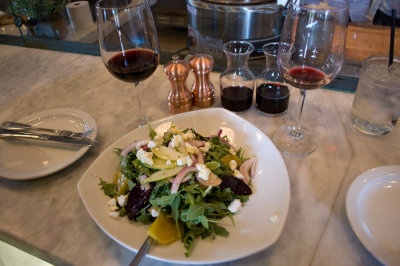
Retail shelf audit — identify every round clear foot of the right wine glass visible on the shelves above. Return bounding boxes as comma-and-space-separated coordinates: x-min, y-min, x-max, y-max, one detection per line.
272, 125, 319, 156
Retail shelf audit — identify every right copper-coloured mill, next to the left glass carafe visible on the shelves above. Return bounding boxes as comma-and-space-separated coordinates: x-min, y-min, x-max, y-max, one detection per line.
189, 54, 215, 107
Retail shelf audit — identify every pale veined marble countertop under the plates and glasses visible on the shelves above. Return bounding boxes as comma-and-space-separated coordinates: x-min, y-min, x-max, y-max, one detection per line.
0, 45, 400, 266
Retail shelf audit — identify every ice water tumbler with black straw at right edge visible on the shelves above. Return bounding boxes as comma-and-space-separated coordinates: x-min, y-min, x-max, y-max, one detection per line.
351, 56, 400, 135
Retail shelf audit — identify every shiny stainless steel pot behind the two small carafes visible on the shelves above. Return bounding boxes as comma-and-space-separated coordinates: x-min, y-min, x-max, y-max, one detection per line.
187, 0, 283, 60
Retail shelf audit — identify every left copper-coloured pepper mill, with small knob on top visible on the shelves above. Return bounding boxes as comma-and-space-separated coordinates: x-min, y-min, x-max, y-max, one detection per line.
164, 55, 192, 114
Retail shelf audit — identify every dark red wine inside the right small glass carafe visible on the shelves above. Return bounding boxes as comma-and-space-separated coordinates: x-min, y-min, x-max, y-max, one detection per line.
256, 82, 290, 116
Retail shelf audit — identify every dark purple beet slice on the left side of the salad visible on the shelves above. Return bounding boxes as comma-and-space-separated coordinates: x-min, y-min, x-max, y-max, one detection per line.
126, 184, 154, 220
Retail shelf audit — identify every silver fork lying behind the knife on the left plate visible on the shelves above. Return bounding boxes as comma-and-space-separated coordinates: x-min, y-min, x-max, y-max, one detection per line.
1, 121, 94, 137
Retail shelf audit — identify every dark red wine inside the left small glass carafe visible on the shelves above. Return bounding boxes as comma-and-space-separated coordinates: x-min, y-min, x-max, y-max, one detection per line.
221, 86, 253, 112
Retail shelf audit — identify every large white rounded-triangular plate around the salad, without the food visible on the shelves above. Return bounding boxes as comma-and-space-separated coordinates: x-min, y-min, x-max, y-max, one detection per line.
78, 108, 290, 264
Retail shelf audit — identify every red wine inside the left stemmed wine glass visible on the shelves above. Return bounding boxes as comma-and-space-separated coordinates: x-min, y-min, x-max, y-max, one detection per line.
106, 49, 158, 82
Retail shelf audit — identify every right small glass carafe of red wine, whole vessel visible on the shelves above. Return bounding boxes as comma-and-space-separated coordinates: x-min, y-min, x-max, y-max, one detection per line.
256, 42, 290, 116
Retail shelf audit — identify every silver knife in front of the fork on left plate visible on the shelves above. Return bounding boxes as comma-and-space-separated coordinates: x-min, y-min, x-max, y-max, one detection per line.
0, 128, 99, 146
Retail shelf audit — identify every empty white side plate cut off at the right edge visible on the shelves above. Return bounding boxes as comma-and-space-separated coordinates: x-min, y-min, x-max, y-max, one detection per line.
346, 166, 400, 265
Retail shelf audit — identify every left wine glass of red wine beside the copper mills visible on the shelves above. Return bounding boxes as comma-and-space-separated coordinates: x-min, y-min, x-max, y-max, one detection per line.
96, 0, 160, 127
